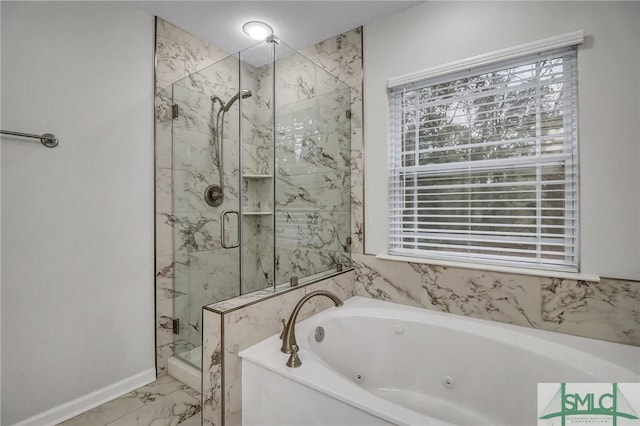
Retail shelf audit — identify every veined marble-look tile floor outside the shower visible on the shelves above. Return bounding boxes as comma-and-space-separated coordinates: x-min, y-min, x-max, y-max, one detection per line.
58, 374, 200, 426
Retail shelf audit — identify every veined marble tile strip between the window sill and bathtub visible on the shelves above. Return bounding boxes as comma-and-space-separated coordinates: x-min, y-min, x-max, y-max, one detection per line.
353, 255, 640, 345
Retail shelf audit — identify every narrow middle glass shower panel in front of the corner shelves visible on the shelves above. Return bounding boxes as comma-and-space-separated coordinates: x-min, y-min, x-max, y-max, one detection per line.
240, 42, 276, 294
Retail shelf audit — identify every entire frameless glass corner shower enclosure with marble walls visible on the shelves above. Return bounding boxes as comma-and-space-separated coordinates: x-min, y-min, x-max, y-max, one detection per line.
172, 38, 351, 369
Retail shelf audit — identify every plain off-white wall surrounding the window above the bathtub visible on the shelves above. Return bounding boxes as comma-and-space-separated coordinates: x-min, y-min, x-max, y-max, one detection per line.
364, 2, 640, 279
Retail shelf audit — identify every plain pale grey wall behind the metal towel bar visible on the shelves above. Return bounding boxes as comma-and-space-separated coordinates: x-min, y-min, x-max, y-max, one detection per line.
1, 1, 154, 425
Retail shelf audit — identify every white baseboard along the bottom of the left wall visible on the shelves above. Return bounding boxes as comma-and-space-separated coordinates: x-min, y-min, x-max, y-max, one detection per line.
13, 368, 156, 426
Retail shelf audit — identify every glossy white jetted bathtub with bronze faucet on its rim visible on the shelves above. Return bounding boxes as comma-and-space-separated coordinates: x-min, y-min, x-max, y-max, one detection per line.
240, 297, 640, 426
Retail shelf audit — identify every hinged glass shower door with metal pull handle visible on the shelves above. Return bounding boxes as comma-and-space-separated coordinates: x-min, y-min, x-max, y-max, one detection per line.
170, 51, 241, 368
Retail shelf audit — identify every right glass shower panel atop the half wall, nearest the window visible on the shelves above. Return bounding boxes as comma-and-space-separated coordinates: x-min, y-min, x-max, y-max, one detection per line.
275, 44, 351, 284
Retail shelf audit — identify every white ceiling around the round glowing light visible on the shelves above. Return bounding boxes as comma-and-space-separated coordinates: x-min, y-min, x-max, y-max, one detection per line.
130, 0, 422, 53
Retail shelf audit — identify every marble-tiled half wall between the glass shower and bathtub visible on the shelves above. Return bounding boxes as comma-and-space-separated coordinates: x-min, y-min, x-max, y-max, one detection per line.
202, 270, 354, 426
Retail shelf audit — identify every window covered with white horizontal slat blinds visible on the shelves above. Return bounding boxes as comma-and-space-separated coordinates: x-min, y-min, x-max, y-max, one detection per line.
389, 47, 578, 271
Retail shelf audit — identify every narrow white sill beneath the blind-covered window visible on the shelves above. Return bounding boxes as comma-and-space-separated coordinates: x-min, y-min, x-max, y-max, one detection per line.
376, 254, 600, 283
